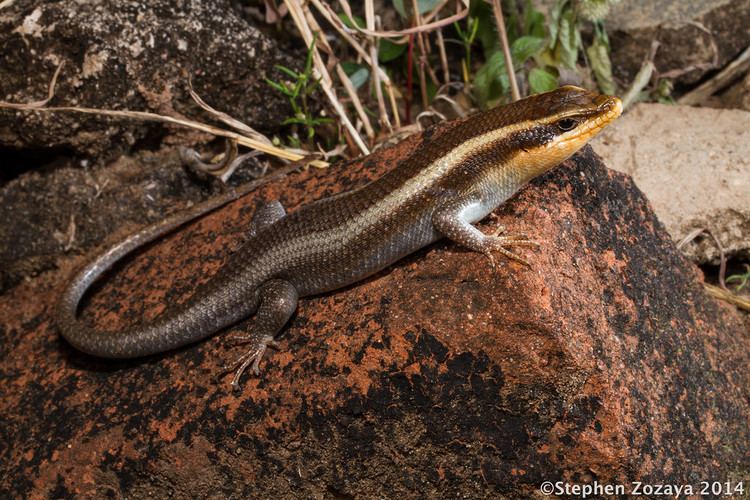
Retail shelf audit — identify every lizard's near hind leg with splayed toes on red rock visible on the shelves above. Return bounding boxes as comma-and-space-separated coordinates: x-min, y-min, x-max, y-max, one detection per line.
229, 279, 298, 389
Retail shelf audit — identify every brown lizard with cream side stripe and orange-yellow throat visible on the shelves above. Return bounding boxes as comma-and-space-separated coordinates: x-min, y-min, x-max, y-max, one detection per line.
57, 87, 622, 384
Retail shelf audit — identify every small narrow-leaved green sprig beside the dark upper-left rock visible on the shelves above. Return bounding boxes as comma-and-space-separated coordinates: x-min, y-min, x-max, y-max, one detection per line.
266, 35, 333, 147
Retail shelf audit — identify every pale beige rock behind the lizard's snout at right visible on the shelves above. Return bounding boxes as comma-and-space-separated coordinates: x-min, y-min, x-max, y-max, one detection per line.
594, 103, 750, 264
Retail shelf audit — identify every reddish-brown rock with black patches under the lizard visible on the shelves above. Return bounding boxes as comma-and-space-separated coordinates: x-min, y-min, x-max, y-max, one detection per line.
0, 132, 750, 498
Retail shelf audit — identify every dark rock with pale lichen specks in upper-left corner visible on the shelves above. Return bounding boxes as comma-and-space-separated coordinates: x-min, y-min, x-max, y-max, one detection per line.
0, 0, 296, 157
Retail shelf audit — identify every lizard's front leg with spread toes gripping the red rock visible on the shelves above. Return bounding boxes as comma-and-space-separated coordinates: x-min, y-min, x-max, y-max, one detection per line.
432, 192, 539, 267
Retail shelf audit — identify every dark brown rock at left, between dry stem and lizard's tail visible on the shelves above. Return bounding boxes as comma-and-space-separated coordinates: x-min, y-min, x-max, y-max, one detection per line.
0, 147, 260, 293
